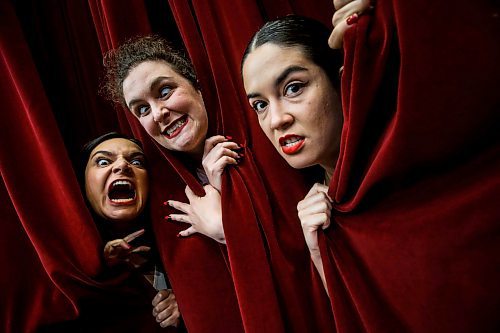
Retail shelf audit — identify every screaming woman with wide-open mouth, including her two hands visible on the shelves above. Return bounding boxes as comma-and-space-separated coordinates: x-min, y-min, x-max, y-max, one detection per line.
81, 132, 180, 327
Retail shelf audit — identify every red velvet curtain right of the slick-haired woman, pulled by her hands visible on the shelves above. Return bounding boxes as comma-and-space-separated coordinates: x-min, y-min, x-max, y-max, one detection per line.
320, 1, 500, 332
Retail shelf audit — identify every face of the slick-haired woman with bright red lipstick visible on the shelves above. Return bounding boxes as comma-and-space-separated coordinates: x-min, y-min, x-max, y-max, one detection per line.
243, 43, 342, 170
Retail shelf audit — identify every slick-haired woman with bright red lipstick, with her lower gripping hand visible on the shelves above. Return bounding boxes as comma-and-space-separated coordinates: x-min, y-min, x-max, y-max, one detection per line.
242, 16, 343, 288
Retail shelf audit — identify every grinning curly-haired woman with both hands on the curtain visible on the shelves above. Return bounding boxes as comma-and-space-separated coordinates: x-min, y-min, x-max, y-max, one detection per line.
103, 36, 242, 243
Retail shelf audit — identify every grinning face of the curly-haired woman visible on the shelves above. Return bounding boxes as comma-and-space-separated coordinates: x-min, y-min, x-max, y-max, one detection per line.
123, 61, 208, 154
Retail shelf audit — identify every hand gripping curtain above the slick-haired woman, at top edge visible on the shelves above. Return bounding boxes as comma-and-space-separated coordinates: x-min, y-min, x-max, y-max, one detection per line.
328, 0, 372, 49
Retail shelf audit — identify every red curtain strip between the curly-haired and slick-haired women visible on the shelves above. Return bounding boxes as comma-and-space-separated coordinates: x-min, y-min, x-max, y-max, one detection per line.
170, 0, 334, 332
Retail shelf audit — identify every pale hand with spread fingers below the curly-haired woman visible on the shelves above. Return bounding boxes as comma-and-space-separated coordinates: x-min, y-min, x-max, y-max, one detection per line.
167, 185, 226, 244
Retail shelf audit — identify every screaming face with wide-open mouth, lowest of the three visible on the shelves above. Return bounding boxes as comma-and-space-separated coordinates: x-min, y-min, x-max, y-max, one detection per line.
85, 138, 149, 222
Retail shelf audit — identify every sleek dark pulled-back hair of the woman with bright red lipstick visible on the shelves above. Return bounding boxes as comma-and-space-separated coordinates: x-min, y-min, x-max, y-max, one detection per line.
241, 15, 343, 88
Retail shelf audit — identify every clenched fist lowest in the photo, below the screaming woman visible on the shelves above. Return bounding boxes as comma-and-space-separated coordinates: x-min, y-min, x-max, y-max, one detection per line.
152, 289, 181, 327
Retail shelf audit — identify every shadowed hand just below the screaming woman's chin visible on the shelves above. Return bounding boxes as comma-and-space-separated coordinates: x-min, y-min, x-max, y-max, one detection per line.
104, 229, 151, 268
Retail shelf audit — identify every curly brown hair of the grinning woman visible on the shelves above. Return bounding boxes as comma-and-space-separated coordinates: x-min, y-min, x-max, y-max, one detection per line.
100, 35, 200, 107
